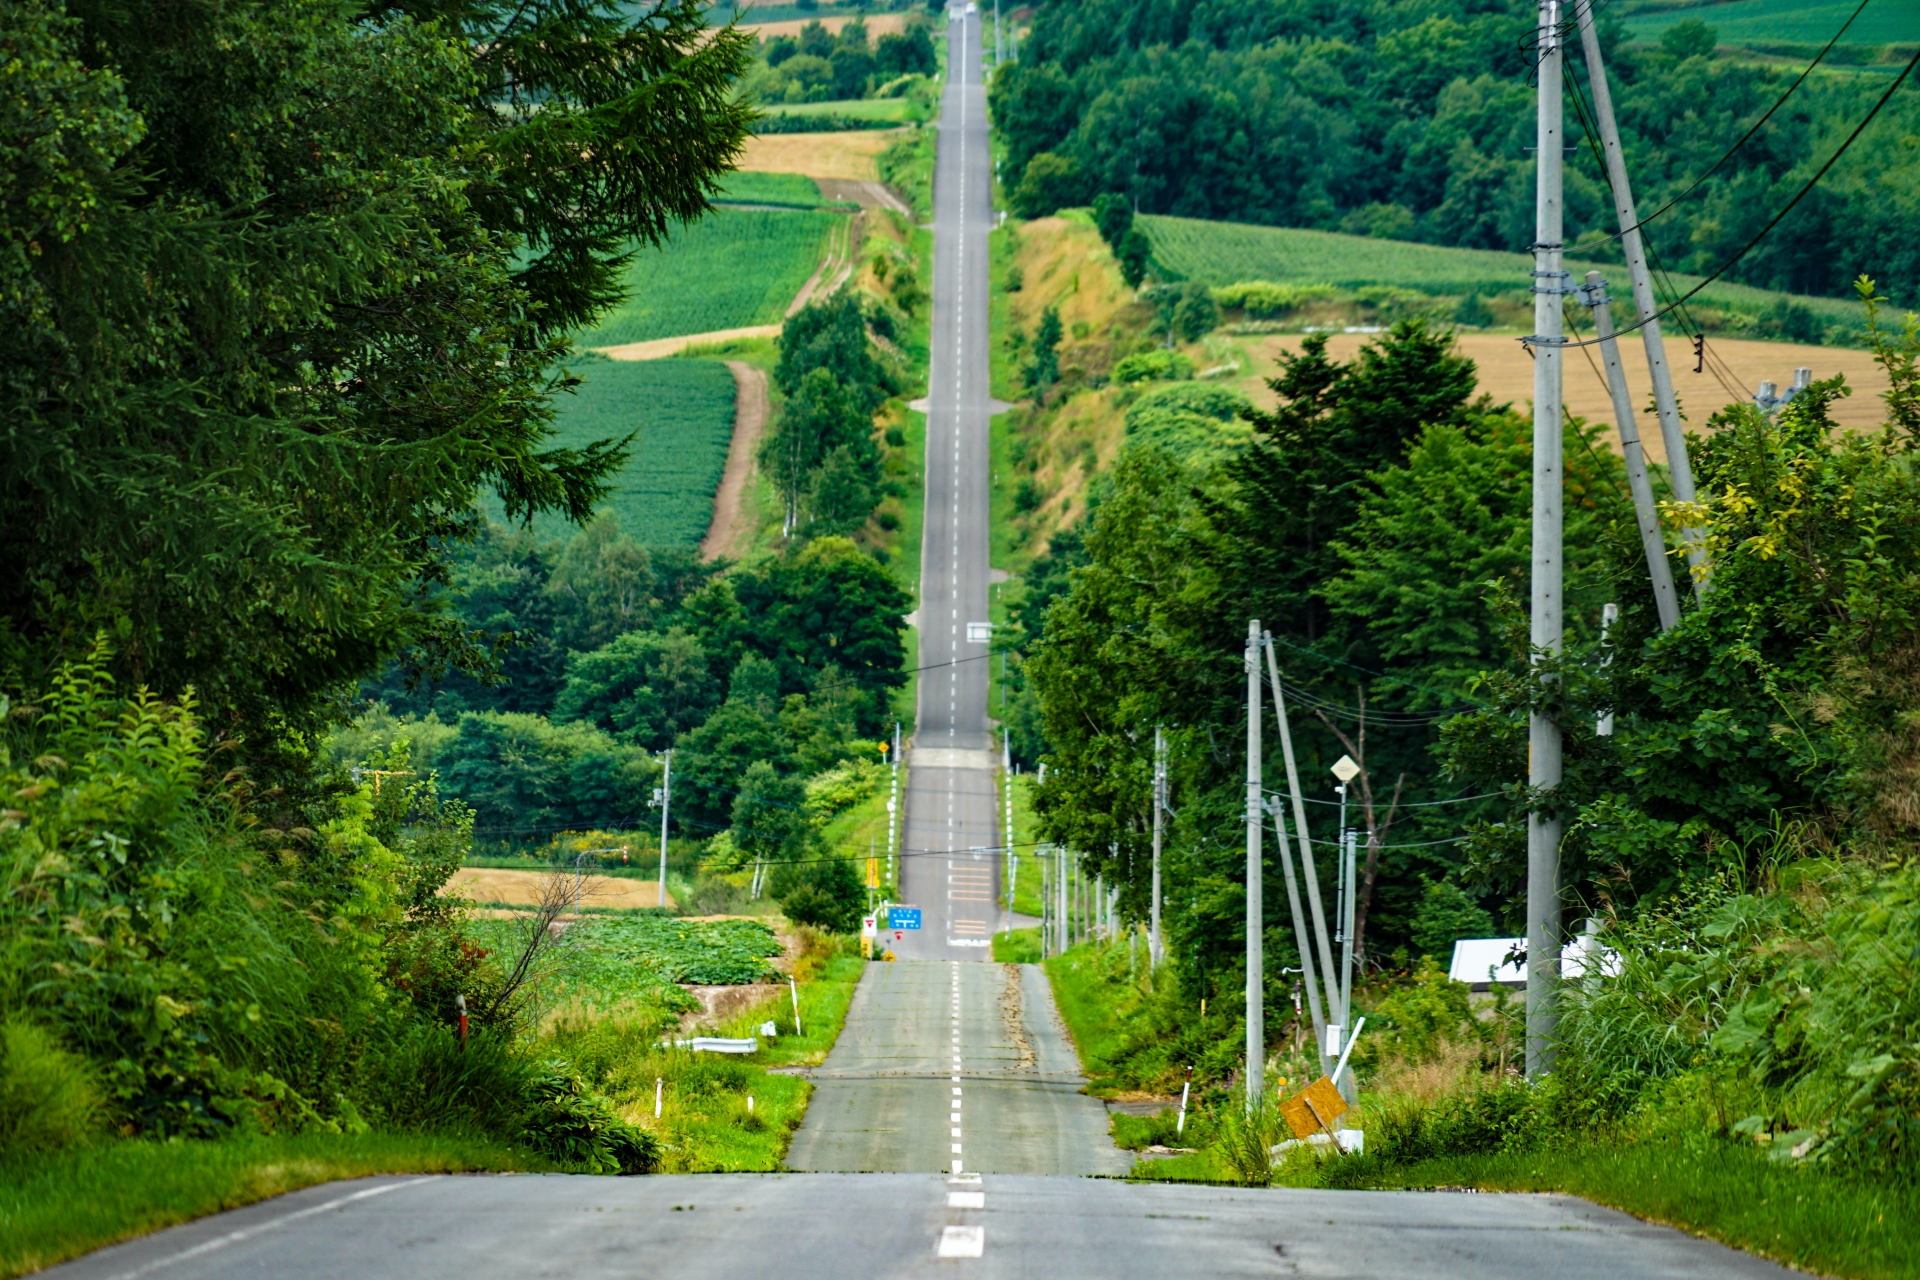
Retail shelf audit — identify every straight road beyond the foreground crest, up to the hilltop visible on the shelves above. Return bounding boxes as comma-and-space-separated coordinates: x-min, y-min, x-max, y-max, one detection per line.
787, 13, 1131, 1174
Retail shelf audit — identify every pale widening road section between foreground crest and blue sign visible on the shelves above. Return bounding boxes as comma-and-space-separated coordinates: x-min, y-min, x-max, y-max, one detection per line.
787, 960, 1133, 1174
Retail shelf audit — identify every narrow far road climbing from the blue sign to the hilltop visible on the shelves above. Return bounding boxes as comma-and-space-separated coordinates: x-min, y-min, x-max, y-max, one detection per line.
887, 0, 1000, 960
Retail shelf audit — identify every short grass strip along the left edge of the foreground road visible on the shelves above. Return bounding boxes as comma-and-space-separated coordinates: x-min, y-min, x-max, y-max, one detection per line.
0, 1134, 553, 1276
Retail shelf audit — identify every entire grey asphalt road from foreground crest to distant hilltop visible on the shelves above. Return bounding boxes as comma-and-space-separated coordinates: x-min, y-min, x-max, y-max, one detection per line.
33, 15, 1791, 1280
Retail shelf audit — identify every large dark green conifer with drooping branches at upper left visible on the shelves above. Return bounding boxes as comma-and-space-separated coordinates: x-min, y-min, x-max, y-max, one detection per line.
0, 0, 749, 760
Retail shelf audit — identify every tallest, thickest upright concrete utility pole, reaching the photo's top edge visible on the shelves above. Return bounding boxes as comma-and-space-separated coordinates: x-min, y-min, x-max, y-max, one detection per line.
1526, 0, 1569, 1080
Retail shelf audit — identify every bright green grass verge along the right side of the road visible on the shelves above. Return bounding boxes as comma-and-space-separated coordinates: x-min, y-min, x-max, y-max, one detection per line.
1046, 932, 1920, 1280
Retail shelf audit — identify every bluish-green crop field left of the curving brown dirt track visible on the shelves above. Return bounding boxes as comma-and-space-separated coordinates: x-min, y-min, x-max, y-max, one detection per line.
510, 361, 733, 547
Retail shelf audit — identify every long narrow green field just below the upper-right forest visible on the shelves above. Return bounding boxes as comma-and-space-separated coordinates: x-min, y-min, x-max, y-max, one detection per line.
1139, 217, 1859, 322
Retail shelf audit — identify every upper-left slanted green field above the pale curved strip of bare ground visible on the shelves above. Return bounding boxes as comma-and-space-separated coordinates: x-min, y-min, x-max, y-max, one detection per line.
574, 209, 839, 347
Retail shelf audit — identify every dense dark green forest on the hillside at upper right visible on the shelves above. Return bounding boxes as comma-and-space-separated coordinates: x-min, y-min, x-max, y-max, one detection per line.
991, 0, 1920, 299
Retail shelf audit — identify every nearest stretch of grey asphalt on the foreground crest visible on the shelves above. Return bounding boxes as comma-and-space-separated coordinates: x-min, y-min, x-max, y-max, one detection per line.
46, 1173, 1793, 1280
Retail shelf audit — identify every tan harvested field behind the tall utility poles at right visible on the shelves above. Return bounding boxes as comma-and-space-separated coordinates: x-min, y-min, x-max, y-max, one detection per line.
1240, 334, 1887, 462
